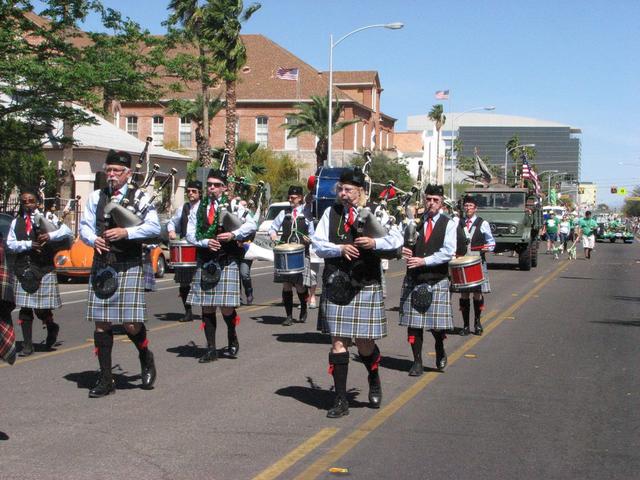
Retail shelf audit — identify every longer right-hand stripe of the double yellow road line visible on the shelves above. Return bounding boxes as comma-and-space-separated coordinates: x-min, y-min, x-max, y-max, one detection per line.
295, 260, 567, 480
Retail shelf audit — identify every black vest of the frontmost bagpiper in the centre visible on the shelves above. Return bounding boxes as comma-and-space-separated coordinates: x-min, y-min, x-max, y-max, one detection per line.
323, 204, 382, 285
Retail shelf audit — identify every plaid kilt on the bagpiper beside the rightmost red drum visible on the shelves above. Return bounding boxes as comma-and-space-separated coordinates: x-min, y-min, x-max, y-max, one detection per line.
400, 275, 453, 330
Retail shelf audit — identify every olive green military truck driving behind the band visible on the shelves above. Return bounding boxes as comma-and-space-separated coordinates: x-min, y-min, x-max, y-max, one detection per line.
465, 185, 543, 270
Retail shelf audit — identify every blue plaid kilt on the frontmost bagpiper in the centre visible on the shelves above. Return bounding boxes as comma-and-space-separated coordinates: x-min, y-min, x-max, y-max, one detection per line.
317, 283, 387, 340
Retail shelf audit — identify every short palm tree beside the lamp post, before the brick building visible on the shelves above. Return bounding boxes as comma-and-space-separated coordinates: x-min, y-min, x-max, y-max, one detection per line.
280, 95, 360, 168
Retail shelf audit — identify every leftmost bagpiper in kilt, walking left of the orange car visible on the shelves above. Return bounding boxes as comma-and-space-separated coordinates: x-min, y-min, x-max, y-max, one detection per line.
7, 188, 73, 357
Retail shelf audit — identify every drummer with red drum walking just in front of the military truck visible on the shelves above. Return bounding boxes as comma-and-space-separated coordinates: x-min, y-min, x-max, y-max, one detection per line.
451, 195, 496, 335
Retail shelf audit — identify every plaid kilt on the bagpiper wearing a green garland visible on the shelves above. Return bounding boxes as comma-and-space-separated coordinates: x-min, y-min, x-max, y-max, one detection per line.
187, 260, 240, 307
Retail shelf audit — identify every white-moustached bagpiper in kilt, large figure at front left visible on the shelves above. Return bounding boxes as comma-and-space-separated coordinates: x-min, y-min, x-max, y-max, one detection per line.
80, 150, 160, 398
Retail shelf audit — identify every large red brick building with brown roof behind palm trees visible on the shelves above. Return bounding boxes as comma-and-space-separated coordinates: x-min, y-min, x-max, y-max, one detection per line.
115, 35, 396, 171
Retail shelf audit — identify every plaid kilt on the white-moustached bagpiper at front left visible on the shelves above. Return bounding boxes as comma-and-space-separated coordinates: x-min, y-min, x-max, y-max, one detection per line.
87, 260, 147, 323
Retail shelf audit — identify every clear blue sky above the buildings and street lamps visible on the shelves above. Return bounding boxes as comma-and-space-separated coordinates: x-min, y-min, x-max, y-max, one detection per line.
51, 0, 640, 205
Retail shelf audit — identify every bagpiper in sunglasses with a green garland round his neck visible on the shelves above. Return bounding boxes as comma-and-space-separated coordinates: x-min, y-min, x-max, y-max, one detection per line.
187, 170, 257, 363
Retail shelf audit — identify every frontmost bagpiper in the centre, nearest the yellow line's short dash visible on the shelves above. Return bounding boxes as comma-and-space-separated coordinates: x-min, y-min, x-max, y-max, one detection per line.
312, 168, 402, 418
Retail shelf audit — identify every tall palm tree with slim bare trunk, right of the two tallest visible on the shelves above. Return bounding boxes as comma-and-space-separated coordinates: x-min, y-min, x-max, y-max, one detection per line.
203, 0, 261, 180
